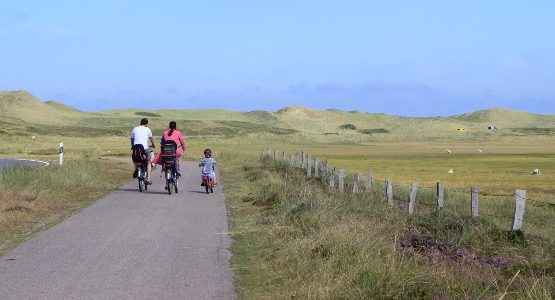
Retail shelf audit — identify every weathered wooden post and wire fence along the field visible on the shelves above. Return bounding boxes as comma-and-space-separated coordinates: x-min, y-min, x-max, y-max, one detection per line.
262, 149, 555, 232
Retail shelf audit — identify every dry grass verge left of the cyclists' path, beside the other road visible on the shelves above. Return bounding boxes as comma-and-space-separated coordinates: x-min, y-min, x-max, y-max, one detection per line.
0, 159, 131, 255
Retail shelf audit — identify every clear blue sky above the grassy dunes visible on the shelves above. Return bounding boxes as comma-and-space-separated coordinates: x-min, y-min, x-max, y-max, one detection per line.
0, 0, 555, 116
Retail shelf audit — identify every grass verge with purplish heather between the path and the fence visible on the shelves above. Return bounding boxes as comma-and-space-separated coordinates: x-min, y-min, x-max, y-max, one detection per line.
220, 154, 555, 299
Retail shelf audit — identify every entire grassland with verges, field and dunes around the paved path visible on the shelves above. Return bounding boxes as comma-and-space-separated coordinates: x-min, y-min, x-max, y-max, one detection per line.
0, 92, 555, 299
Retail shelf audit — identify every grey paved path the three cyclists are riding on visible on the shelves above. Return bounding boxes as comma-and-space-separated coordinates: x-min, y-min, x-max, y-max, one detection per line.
0, 163, 235, 299
